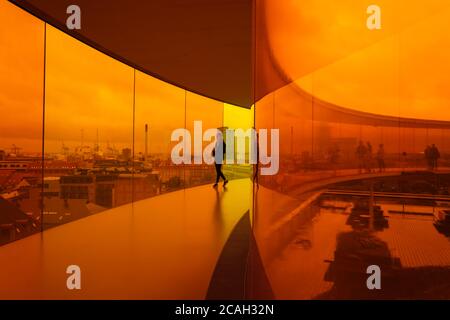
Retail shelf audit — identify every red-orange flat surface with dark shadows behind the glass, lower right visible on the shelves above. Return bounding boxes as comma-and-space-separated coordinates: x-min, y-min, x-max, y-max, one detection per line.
266, 198, 450, 299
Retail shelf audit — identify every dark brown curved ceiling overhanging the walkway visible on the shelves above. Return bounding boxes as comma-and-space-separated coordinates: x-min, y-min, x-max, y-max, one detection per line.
10, 0, 253, 107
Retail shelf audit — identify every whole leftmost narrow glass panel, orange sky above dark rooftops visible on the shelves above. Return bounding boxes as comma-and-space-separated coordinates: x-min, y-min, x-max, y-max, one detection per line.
0, 1, 44, 245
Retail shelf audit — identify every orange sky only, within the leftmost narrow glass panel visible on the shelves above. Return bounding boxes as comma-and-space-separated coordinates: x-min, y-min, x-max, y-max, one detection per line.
0, 1, 44, 152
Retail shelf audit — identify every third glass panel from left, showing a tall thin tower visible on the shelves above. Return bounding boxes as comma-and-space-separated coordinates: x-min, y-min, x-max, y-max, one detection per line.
134, 72, 185, 201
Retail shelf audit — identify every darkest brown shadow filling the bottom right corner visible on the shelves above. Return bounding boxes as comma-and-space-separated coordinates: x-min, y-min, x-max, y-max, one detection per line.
315, 230, 450, 299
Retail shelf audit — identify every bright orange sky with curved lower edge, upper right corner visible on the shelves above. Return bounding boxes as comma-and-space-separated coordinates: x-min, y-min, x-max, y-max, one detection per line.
265, 0, 450, 120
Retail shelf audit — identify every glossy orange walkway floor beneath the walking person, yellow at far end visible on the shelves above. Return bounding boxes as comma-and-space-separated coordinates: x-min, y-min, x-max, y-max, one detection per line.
0, 179, 252, 299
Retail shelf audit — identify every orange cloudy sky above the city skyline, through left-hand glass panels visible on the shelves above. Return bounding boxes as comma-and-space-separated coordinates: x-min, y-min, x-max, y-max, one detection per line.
0, 1, 224, 154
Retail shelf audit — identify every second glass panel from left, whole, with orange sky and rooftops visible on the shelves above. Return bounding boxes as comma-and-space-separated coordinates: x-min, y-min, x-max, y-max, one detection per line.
44, 26, 133, 227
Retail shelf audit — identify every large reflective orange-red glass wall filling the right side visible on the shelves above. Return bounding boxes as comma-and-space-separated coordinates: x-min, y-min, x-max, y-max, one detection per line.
254, 0, 450, 299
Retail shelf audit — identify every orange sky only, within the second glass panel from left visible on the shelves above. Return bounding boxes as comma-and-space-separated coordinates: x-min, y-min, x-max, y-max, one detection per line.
45, 26, 133, 152
